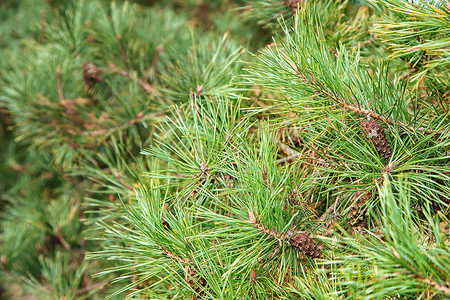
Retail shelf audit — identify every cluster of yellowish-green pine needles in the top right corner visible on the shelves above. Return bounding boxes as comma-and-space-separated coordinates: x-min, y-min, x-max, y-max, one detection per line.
374, 0, 450, 88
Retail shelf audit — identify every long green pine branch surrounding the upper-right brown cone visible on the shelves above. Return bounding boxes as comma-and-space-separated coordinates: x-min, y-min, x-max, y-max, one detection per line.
249, 5, 449, 211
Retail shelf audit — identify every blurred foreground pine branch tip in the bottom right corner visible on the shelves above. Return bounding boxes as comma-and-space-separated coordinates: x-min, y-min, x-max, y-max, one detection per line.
316, 176, 450, 299
